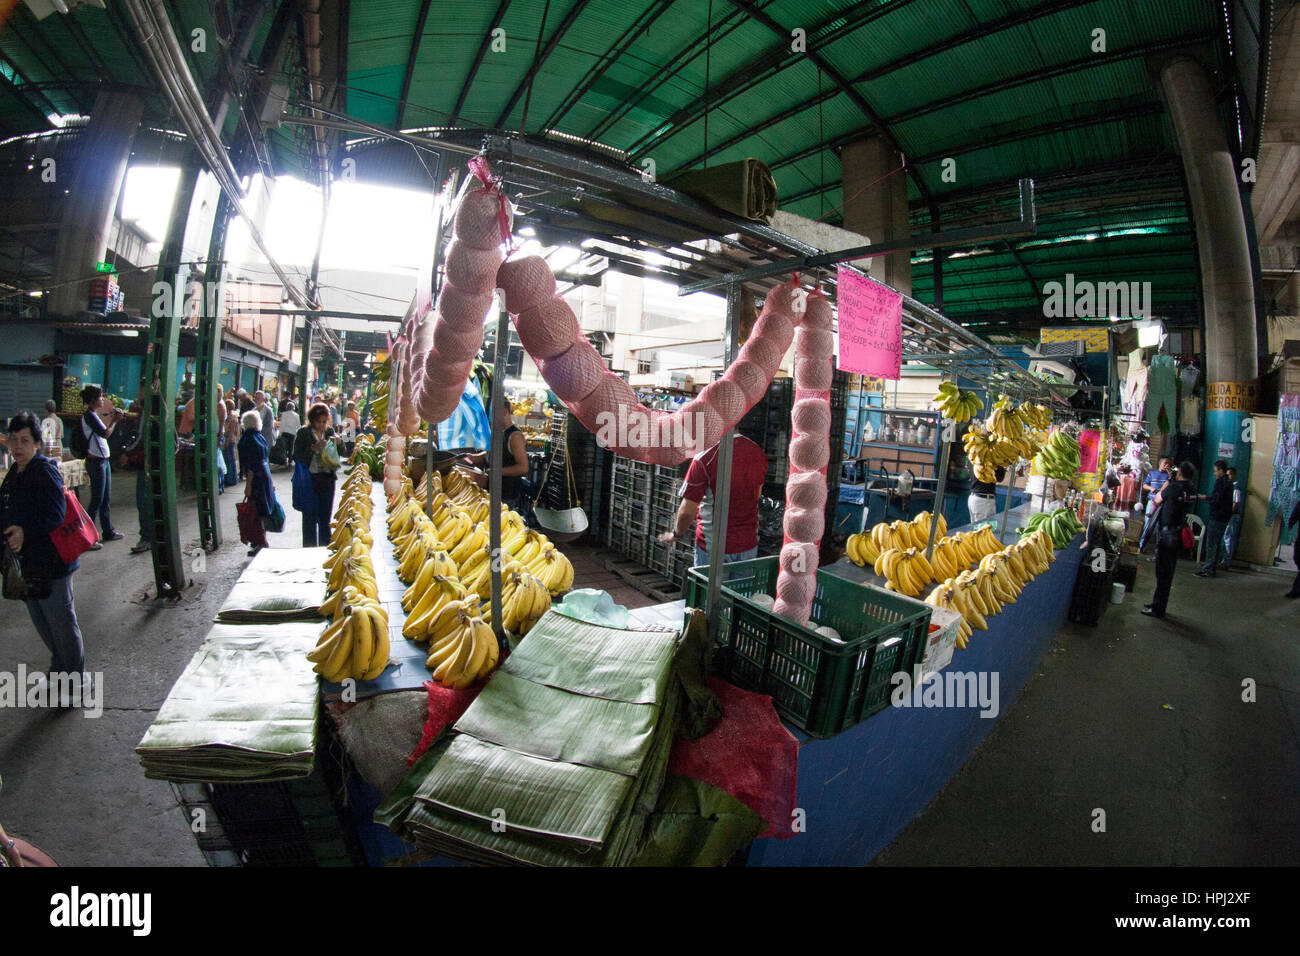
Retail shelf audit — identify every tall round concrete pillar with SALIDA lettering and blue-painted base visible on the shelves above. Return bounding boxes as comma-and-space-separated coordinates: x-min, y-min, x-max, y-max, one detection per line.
1154, 56, 1260, 502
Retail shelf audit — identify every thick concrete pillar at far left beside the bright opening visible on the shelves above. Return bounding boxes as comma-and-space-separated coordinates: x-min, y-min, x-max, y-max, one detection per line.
49, 92, 144, 316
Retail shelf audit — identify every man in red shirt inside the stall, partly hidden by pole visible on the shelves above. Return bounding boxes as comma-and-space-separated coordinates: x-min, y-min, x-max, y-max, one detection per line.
659, 434, 767, 566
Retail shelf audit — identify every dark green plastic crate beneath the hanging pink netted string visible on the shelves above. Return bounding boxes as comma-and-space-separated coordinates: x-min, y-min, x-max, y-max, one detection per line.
686, 557, 930, 737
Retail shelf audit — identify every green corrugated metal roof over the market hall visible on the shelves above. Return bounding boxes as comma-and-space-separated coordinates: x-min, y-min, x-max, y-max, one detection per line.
0, 0, 1225, 325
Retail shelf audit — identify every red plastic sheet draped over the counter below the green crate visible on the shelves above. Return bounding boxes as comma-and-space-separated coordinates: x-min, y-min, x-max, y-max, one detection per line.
668, 678, 800, 840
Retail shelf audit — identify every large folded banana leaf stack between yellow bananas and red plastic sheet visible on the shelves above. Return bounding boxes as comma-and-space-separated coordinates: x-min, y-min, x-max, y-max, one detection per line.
374, 611, 681, 866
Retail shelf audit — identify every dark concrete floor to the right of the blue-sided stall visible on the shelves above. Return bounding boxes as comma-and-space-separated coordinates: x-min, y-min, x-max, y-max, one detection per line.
875, 562, 1300, 866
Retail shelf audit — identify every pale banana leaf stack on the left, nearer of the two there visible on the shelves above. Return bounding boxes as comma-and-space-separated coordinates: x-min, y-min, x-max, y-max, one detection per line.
135, 622, 320, 783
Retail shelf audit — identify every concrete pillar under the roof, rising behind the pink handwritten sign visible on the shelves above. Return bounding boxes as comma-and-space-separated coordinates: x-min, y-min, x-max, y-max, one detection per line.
840, 137, 911, 295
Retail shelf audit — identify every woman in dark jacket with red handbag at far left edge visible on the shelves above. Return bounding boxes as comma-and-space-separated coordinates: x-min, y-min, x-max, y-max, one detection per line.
0, 411, 86, 675
